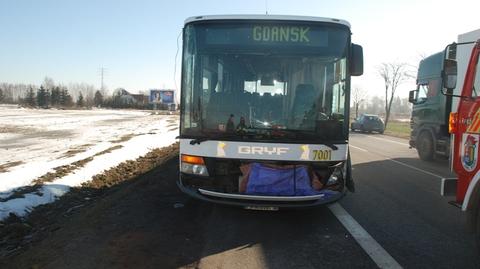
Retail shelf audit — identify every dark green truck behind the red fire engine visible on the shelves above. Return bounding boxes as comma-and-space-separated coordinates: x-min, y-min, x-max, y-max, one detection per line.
409, 29, 480, 161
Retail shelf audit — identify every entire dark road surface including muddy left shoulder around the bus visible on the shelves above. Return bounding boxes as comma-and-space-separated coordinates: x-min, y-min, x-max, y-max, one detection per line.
0, 133, 480, 268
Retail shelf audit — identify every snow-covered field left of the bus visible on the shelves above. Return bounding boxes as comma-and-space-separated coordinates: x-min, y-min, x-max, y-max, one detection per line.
0, 106, 178, 220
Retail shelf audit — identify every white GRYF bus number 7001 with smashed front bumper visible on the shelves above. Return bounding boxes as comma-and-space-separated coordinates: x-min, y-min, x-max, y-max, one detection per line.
177, 15, 363, 210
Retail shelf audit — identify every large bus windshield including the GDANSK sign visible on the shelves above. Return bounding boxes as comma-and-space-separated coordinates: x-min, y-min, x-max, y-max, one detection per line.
181, 22, 350, 141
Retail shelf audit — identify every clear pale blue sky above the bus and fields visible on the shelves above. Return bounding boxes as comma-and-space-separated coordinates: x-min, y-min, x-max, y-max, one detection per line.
0, 0, 480, 97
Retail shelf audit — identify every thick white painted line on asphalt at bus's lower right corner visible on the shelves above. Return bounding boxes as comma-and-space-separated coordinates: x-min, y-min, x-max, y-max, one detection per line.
328, 203, 402, 268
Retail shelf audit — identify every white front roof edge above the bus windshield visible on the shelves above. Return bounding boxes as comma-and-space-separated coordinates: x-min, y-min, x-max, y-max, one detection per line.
185, 15, 350, 28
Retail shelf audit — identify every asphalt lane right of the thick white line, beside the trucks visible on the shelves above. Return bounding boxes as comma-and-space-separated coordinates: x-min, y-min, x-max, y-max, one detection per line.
340, 134, 480, 268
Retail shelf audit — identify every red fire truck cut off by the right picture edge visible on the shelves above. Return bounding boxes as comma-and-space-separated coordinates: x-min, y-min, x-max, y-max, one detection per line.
441, 39, 480, 247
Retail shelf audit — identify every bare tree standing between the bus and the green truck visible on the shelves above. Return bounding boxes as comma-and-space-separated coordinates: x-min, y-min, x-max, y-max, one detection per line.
377, 63, 413, 128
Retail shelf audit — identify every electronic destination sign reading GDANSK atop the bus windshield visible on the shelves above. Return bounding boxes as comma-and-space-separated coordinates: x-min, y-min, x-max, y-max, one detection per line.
201, 24, 330, 48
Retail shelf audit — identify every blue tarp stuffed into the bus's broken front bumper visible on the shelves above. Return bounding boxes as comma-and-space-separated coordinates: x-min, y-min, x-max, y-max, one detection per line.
246, 163, 322, 196
